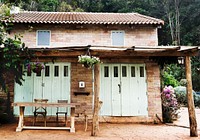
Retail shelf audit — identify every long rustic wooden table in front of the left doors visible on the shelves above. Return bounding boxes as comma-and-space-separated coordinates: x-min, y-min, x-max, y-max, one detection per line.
13, 102, 78, 132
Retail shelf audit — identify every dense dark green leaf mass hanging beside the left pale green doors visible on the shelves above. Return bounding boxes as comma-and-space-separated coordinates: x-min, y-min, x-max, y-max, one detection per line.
0, 36, 30, 91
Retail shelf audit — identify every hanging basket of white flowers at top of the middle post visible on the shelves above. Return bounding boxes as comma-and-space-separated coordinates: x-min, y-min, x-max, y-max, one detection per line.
78, 55, 101, 68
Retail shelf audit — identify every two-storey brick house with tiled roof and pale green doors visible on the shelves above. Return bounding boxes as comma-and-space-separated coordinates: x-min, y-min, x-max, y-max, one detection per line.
8, 12, 167, 122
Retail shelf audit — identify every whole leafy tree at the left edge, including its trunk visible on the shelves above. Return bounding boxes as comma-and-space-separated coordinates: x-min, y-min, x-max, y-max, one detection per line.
0, 5, 31, 120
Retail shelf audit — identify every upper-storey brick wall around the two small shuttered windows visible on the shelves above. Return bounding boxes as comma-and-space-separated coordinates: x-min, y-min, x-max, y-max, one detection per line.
12, 24, 158, 48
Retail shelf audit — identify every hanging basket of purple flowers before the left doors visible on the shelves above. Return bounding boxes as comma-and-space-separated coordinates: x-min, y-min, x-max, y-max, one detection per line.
27, 62, 44, 73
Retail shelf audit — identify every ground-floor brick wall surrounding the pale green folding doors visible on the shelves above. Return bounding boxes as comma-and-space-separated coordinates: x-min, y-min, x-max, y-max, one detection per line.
6, 57, 162, 122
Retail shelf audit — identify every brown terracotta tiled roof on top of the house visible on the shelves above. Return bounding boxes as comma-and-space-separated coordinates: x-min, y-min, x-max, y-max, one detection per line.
7, 12, 164, 25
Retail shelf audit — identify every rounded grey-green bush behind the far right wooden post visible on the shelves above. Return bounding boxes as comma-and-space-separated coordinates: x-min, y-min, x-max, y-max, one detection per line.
174, 86, 200, 107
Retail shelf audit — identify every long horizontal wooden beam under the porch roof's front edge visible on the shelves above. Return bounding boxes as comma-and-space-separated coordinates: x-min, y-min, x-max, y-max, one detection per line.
28, 48, 198, 58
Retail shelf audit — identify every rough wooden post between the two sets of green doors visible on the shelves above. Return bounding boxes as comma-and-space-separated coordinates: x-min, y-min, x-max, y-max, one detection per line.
91, 64, 100, 136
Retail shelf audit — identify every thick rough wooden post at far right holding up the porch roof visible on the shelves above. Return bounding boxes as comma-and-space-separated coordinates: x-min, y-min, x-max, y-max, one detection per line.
185, 56, 198, 137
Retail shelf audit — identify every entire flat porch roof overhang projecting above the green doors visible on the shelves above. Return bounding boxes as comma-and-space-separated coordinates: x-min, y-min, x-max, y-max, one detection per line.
29, 45, 200, 57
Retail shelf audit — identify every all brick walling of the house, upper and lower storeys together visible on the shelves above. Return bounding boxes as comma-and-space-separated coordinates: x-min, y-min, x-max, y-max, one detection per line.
11, 24, 162, 122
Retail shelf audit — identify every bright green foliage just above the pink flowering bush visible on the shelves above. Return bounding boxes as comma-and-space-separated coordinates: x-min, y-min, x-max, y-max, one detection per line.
163, 72, 179, 87
